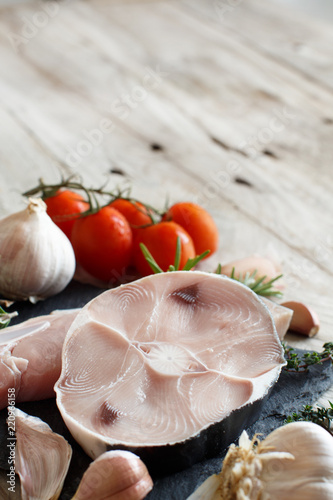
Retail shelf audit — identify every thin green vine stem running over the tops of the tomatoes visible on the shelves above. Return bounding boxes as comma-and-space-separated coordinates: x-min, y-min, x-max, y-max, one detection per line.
23, 175, 162, 223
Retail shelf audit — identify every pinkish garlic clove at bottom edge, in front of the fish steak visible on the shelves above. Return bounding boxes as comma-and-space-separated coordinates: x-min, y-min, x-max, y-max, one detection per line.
73, 450, 153, 500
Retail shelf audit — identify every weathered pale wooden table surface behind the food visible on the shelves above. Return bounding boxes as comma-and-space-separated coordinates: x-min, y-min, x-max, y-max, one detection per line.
0, 0, 333, 404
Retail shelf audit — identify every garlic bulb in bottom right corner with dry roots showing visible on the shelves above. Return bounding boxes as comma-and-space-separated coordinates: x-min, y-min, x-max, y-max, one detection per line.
188, 422, 333, 500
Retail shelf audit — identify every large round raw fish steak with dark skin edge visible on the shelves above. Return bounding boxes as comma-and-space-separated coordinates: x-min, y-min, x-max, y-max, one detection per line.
55, 271, 285, 470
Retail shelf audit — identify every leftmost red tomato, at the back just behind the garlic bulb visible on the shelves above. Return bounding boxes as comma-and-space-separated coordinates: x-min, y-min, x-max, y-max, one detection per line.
45, 189, 89, 239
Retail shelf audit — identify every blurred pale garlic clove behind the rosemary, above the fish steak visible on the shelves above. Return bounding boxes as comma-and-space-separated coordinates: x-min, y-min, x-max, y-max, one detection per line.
222, 255, 281, 282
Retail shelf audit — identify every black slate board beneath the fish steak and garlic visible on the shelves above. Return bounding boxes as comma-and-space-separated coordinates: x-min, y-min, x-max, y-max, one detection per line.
0, 281, 333, 500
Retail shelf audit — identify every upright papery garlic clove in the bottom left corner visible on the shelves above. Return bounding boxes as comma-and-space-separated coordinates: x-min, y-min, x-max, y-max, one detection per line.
15, 408, 72, 500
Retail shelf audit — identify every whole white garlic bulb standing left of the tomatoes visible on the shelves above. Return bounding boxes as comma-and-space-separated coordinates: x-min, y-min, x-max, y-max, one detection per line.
0, 198, 75, 303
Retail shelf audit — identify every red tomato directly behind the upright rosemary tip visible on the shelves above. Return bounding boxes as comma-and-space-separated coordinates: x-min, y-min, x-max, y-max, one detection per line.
134, 222, 195, 276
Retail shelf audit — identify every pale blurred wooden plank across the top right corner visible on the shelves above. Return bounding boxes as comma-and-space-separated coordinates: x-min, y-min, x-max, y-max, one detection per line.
182, 0, 333, 91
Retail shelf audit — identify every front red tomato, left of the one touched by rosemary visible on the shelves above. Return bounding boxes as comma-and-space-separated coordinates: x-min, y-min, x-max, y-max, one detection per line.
72, 206, 133, 282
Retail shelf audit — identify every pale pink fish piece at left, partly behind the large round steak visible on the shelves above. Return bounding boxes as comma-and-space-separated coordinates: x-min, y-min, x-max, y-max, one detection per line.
0, 309, 79, 409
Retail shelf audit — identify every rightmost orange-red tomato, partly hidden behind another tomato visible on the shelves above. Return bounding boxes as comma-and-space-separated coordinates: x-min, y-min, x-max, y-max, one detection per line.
163, 202, 218, 258
